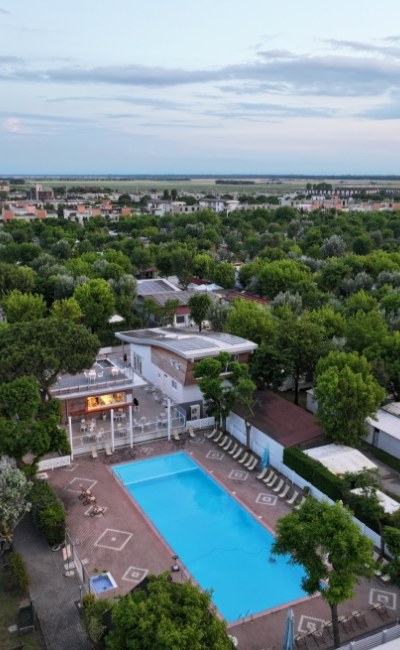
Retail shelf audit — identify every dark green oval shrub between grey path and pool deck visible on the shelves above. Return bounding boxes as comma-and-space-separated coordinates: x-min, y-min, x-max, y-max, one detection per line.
29, 480, 65, 546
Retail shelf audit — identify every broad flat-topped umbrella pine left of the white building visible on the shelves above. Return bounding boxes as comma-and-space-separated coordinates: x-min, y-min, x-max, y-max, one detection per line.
0, 318, 100, 400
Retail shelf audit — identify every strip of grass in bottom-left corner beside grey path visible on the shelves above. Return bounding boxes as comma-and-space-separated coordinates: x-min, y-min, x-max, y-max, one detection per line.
0, 564, 46, 650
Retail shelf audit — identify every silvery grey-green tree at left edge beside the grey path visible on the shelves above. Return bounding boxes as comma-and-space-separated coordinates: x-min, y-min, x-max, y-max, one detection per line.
0, 463, 32, 544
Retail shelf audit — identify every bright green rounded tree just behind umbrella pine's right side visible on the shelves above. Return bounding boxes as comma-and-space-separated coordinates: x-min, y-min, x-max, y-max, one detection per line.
74, 278, 115, 331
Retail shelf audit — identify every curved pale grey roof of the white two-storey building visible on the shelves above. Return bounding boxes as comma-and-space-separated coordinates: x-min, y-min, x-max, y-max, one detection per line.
115, 327, 258, 359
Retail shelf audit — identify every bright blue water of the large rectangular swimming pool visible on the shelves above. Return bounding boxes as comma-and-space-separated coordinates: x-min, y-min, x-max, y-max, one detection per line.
113, 452, 305, 623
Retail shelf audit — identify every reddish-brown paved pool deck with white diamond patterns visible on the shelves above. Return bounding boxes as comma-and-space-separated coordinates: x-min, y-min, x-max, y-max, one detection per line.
48, 434, 400, 650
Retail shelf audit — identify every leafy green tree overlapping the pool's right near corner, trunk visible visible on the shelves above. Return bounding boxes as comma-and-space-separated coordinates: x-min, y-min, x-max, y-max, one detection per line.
272, 497, 374, 648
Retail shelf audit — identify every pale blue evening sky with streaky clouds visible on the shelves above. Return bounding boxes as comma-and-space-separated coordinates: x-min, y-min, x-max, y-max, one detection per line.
0, 0, 400, 176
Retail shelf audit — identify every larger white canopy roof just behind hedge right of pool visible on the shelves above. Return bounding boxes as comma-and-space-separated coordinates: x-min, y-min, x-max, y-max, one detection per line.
304, 445, 378, 476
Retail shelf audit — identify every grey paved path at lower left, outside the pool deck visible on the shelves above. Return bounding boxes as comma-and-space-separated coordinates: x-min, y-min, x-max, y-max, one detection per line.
14, 515, 92, 650
